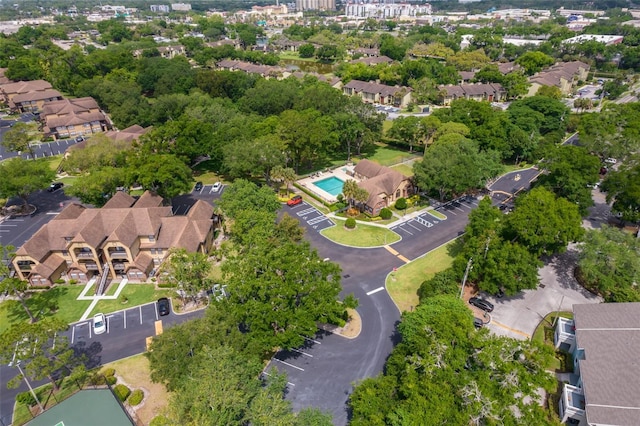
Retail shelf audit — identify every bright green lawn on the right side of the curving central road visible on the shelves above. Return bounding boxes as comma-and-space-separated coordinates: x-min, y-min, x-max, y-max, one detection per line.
386, 243, 453, 312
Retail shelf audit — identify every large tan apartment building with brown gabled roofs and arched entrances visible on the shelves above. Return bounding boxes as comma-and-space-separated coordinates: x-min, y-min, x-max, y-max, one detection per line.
12, 191, 218, 286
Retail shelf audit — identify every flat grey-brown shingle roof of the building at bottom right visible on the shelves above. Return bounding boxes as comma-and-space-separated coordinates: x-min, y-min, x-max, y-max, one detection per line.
573, 303, 640, 425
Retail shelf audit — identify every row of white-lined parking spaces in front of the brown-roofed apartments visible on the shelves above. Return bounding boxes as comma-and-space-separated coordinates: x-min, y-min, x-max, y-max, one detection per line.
69, 302, 160, 345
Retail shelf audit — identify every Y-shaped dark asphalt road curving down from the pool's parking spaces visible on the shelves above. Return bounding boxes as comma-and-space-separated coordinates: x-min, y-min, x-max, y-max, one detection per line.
278, 200, 477, 425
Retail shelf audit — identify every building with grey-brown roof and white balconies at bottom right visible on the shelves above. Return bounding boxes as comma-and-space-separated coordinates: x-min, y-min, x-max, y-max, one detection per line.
554, 303, 640, 426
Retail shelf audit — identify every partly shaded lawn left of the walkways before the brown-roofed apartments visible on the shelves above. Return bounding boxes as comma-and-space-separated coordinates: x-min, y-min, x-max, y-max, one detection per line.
0, 284, 91, 333
